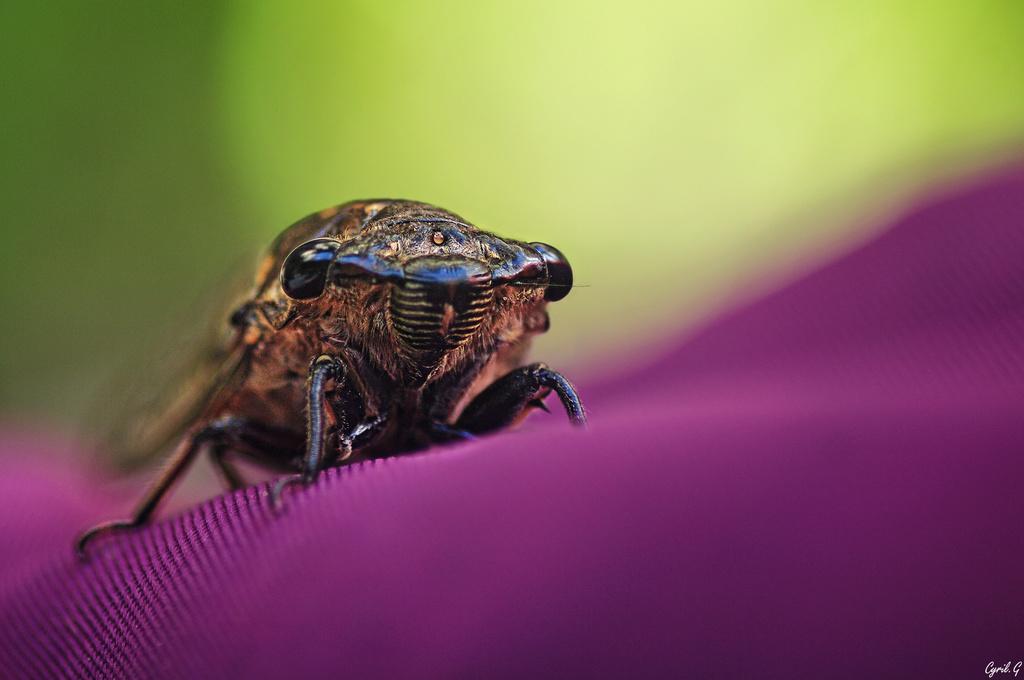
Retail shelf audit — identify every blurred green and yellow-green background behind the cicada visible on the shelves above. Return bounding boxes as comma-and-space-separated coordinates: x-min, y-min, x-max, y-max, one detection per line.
0, 0, 1024, 423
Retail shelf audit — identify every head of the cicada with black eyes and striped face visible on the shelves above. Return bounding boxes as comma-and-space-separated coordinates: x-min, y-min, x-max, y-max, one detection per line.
268, 201, 572, 385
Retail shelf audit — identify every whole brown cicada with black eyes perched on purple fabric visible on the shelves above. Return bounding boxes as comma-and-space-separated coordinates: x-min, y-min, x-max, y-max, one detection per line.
77, 200, 587, 555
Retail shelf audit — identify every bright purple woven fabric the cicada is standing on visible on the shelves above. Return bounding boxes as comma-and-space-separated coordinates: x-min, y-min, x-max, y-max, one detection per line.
0, 168, 1024, 678
